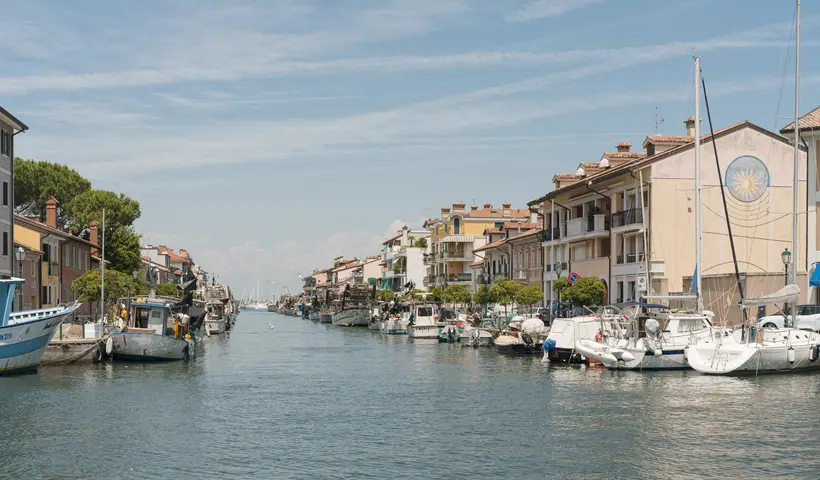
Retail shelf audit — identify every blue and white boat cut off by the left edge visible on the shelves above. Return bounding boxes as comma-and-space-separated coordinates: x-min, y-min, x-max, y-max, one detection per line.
0, 278, 80, 375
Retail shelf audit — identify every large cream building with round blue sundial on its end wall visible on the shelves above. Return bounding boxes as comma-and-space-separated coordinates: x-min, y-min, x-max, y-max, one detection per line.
530, 118, 817, 320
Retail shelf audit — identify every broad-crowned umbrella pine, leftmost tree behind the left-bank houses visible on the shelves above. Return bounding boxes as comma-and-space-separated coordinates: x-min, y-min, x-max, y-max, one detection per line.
14, 158, 91, 226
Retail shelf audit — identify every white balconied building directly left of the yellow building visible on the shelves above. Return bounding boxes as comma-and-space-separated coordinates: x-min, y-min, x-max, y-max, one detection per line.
379, 225, 430, 291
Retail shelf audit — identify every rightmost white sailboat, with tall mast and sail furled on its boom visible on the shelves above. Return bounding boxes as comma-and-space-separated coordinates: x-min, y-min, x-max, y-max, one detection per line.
688, 0, 820, 375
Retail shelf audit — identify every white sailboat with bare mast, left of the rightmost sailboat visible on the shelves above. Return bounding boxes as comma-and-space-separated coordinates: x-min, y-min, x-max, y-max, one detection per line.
575, 57, 714, 370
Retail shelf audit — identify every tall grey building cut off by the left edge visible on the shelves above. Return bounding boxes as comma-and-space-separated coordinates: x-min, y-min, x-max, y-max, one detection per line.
0, 106, 28, 276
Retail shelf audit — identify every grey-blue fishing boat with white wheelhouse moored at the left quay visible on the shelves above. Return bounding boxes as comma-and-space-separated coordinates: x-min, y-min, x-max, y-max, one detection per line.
111, 298, 196, 362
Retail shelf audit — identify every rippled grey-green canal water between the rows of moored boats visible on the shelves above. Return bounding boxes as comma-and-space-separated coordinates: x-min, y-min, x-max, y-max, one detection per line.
0, 312, 820, 480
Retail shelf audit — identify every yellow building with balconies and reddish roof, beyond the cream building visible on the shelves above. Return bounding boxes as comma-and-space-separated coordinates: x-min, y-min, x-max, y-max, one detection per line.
424, 202, 531, 289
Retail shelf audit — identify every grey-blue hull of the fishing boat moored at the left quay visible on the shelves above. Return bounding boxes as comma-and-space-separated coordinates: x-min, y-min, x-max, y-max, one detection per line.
111, 332, 193, 362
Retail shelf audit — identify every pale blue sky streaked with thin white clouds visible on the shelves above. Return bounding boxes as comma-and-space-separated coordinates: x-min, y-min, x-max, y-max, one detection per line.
0, 0, 820, 295
